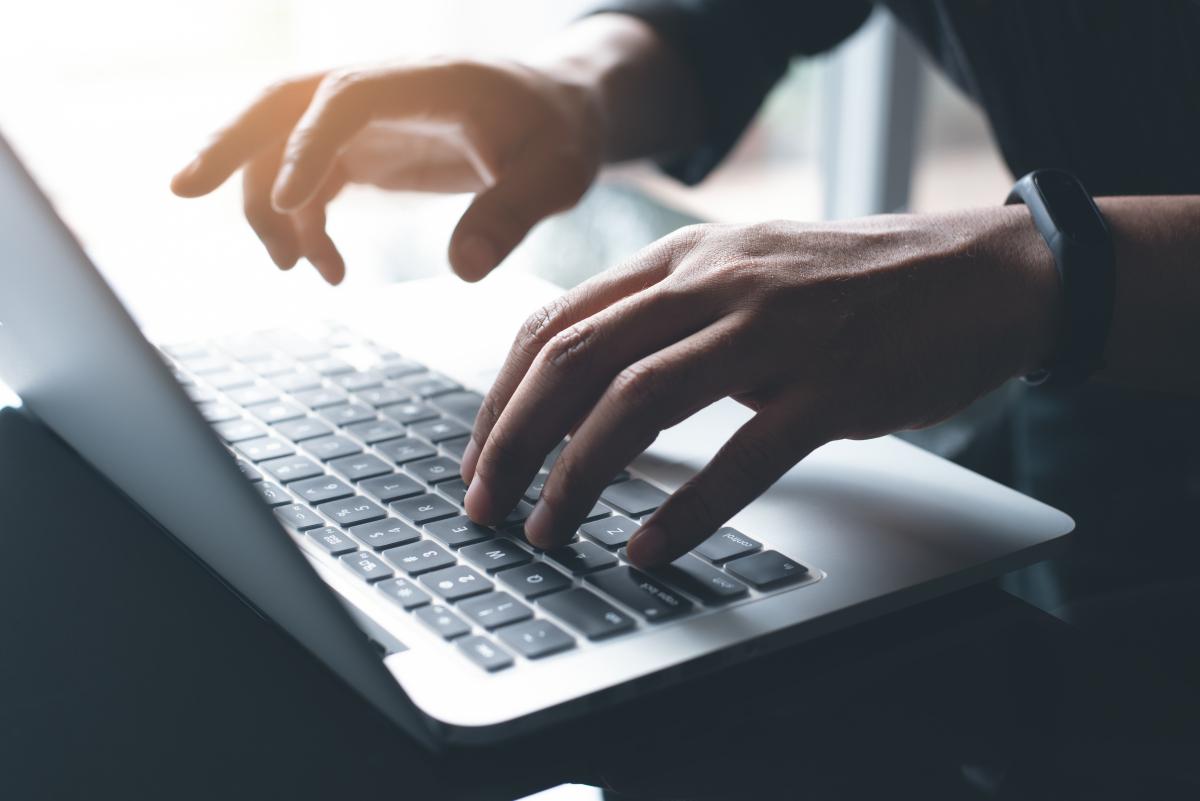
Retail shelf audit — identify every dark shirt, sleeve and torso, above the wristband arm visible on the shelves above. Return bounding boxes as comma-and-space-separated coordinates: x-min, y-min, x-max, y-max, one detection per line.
606, 0, 1200, 194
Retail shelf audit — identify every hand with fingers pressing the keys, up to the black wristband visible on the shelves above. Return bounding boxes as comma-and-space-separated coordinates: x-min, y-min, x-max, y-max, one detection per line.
462, 207, 1058, 565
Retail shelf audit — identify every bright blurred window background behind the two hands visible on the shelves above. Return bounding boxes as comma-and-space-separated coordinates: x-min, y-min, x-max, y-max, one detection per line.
0, 0, 1009, 315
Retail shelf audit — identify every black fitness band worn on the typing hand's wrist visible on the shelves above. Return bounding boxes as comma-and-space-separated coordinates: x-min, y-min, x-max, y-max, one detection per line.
1006, 169, 1116, 386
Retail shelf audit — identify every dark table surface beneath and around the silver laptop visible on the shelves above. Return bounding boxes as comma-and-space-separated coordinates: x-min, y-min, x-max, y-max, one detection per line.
0, 409, 1200, 801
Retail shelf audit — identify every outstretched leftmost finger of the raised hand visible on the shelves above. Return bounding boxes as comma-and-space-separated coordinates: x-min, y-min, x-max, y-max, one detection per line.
170, 74, 322, 198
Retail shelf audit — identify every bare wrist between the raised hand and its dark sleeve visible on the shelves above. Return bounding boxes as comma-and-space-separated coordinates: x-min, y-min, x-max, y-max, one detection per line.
530, 14, 702, 162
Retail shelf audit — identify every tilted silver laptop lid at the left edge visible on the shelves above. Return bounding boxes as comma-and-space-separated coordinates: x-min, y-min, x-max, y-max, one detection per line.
0, 135, 428, 735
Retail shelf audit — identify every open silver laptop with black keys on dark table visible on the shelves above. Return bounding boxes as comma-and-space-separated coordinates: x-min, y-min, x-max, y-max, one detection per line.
0, 131, 1073, 747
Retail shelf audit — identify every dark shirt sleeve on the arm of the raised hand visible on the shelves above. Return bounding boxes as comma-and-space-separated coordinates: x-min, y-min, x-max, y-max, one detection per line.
592, 0, 872, 183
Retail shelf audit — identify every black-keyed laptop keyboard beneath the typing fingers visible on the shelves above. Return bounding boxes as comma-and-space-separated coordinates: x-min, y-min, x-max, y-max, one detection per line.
162, 325, 814, 671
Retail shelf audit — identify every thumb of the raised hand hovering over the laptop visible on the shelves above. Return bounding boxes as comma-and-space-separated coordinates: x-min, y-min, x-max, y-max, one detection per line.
449, 147, 595, 282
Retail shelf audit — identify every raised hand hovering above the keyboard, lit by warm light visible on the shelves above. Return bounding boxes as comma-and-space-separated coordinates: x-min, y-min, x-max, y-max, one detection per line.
172, 59, 604, 284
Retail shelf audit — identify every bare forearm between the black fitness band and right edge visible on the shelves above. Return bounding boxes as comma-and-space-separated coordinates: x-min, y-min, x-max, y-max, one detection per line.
1097, 195, 1200, 396
